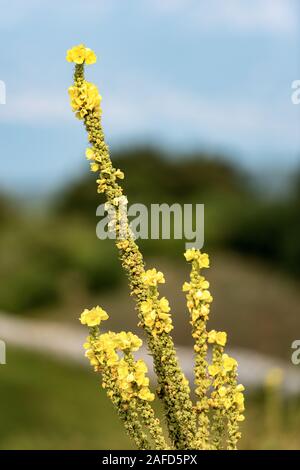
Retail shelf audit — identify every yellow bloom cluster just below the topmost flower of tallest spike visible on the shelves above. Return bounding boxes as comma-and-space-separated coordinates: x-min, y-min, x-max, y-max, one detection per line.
69, 81, 102, 119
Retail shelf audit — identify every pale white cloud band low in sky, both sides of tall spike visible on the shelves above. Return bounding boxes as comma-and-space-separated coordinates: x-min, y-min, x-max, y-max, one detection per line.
0, 76, 300, 165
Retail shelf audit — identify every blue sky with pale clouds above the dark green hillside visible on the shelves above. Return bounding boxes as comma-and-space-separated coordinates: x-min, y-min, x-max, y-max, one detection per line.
0, 0, 300, 192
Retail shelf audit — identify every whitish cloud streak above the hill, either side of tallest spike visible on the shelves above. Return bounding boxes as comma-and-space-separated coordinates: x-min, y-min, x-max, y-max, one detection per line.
0, 83, 299, 146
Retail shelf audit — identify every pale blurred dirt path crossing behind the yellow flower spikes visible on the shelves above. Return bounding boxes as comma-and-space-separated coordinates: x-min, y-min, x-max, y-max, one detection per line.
0, 313, 300, 393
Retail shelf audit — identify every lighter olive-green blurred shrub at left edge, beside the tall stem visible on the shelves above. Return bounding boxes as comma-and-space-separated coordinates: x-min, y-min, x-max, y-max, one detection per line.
0, 218, 121, 313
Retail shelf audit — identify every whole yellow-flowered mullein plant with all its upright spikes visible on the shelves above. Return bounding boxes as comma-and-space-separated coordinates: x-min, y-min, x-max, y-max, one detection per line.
66, 44, 244, 450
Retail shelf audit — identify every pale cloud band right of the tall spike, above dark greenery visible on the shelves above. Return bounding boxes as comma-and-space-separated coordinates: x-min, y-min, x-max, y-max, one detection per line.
104, 82, 300, 158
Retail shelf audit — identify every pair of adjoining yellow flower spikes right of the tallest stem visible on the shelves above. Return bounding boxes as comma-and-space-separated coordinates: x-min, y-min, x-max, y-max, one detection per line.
183, 249, 244, 449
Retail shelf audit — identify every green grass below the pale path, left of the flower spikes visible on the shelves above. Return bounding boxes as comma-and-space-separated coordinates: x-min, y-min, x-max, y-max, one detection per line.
0, 349, 130, 449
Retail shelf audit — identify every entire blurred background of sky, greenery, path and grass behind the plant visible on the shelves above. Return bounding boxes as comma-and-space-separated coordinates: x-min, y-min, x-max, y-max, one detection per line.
0, 0, 300, 449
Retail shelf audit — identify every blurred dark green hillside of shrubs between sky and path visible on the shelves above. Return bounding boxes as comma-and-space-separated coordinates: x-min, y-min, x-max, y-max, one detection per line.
0, 147, 300, 314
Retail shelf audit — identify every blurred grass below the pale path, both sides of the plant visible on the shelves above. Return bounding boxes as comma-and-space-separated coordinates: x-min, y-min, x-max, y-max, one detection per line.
0, 348, 300, 449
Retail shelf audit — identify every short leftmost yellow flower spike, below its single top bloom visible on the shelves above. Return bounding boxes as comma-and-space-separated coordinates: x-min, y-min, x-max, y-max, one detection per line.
84, 329, 168, 450
